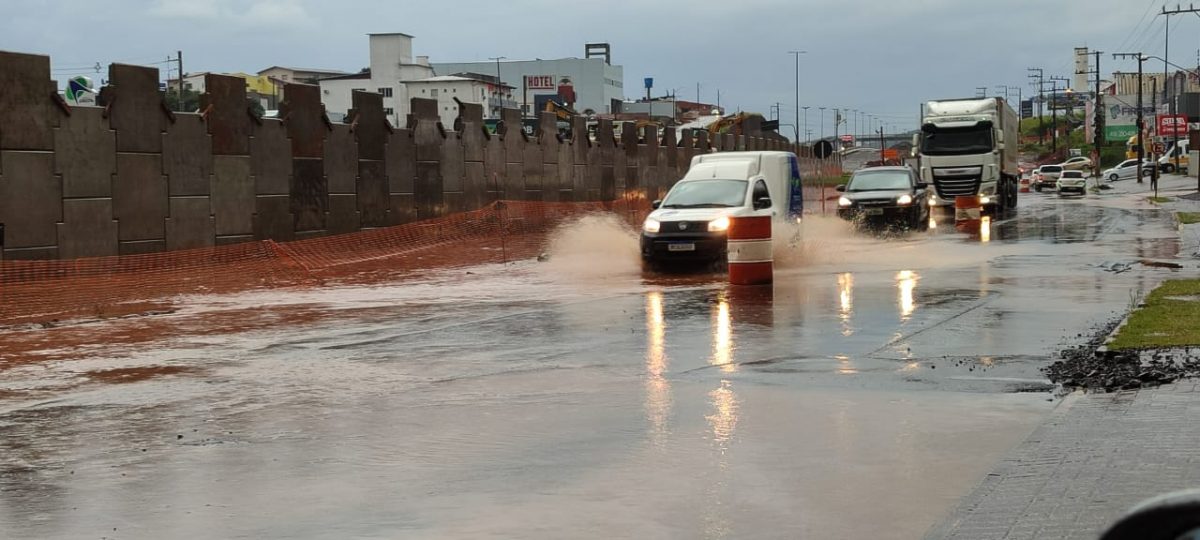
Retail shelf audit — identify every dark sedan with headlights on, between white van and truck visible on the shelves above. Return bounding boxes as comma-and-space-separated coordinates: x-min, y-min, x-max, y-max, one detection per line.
838, 167, 929, 230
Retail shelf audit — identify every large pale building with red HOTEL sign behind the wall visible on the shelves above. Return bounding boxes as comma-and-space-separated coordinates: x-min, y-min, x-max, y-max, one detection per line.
433, 44, 625, 114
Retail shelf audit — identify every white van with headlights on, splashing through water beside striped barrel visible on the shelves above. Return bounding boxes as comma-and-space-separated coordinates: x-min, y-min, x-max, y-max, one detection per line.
642, 151, 804, 263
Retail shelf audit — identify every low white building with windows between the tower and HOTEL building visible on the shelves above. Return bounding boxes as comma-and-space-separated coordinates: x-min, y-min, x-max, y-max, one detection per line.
404, 73, 517, 124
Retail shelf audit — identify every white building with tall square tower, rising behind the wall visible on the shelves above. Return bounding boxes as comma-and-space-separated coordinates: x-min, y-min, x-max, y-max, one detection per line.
318, 32, 434, 126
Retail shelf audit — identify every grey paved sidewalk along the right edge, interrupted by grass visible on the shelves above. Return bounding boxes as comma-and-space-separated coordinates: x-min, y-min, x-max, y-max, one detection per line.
926, 175, 1200, 540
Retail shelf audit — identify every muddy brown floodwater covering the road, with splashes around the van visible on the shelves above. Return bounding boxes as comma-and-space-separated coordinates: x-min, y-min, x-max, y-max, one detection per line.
0, 196, 1177, 539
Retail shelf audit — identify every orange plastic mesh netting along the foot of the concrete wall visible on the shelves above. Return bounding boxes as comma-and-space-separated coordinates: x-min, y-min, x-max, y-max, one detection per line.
0, 199, 649, 326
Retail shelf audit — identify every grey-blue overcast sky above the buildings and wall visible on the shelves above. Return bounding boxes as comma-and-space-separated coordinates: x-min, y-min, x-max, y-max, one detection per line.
0, 0, 1180, 131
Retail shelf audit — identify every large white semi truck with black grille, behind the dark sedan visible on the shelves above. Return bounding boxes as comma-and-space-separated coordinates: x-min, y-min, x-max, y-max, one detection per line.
913, 97, 1020, 214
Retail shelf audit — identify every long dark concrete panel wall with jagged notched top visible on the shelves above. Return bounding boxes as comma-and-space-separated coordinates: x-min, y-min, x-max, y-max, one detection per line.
0, 52, 816, 259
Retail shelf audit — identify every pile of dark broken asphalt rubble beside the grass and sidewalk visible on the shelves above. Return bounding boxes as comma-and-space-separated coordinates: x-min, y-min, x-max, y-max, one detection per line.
1043, 323, 1200, 392
